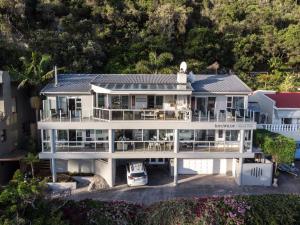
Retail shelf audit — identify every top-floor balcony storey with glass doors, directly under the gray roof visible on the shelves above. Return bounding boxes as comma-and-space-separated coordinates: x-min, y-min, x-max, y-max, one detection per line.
40, 93, 254, 122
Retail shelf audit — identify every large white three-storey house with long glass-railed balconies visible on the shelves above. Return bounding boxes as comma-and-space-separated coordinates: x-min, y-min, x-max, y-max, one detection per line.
38, 68, 271, 186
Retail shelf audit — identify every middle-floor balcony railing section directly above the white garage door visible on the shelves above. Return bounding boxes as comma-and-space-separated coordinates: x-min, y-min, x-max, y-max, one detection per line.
179, 140, 240, 152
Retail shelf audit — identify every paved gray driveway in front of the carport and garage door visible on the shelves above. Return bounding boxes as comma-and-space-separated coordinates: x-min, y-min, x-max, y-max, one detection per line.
71, 171, 300, 205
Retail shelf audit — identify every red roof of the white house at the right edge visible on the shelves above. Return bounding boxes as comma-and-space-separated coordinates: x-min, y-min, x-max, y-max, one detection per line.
266, 92, 300, 108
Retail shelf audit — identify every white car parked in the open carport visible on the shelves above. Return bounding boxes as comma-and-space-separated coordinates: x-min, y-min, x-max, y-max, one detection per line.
126, 162, 148, 186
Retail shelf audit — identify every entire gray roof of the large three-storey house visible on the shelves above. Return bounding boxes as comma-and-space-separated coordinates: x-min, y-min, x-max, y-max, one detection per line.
41, 74, 251, 94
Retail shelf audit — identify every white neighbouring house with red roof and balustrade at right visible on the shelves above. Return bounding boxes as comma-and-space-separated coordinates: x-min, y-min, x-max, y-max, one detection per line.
249, 90, 300, 158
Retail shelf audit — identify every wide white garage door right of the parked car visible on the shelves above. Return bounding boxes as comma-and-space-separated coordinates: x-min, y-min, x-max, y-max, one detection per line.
178, 159, 234, 175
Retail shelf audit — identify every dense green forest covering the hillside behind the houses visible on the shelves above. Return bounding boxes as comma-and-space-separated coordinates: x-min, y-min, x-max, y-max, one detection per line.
0, 0, 300, 91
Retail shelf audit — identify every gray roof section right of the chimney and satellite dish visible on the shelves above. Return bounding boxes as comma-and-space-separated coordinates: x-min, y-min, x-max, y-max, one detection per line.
192, 75, 252, 93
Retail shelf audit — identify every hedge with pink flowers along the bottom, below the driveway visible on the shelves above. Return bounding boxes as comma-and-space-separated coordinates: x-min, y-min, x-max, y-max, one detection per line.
0, 195, 300, 225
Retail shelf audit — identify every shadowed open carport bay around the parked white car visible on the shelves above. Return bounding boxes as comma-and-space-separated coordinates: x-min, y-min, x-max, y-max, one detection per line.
115, 159, 173, 186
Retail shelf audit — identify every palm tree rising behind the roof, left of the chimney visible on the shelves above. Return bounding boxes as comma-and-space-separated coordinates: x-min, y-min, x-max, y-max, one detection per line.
135, 52, 174, 74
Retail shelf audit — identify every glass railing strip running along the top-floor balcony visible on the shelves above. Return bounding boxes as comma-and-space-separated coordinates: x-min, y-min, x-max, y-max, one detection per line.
40, 108, 254, 122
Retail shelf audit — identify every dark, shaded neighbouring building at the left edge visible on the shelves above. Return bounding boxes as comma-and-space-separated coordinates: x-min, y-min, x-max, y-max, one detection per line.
0, 71, 32, 184
